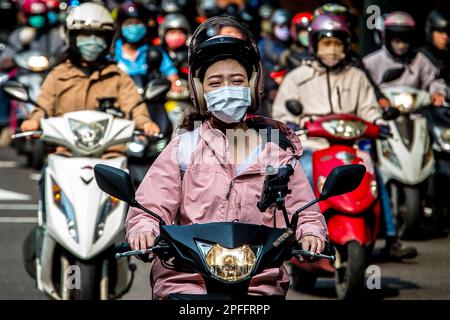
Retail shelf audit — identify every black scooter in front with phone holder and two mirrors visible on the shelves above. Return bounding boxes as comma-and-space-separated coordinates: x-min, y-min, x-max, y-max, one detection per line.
94, 165, 365, 300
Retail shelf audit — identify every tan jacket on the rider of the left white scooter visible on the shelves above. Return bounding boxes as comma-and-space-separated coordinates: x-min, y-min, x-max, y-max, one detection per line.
31, 60, 150, 128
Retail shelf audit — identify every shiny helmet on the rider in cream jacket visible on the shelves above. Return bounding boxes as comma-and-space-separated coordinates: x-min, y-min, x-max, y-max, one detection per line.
308, 14, 351, 53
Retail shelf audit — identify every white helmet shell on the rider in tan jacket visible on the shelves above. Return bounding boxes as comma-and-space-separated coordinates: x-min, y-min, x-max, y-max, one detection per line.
66, 2, 114, 31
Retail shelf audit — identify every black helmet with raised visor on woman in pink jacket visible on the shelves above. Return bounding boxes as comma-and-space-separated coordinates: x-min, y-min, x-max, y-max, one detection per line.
188, 17, 263, 114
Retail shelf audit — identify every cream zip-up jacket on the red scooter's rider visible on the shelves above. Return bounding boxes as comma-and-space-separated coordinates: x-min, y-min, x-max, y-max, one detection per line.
272, 60, 381, 125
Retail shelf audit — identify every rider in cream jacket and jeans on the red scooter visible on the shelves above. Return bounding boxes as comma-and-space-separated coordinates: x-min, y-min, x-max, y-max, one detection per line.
272, 14, 417, 260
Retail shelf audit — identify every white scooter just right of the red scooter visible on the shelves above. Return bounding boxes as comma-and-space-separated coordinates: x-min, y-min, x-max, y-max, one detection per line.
377, 86, 434, 237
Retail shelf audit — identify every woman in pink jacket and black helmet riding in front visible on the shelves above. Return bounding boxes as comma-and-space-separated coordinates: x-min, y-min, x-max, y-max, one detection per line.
126, 17, 327, 299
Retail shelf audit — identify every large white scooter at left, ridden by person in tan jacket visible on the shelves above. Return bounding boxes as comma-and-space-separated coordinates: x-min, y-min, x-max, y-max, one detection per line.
4, 82, 136, 300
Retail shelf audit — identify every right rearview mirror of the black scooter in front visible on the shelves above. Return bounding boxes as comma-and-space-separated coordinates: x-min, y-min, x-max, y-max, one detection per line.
319, 164, 366, 200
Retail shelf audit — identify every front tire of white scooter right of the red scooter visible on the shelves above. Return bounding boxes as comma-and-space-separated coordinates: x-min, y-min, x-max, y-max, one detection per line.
399, 186, 422, 239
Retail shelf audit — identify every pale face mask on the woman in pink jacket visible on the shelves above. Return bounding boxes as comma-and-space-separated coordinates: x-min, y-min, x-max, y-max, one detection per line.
205, 86, 251, 123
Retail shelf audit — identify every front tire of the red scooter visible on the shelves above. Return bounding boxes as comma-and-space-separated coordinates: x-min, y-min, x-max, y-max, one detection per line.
335, 241, 366, 300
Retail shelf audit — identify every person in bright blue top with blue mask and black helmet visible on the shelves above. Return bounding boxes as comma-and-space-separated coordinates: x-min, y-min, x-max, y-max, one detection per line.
113, 1, 179, 94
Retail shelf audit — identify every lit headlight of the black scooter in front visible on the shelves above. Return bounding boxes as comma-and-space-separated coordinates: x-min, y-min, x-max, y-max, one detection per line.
197, 242, 262, 282
